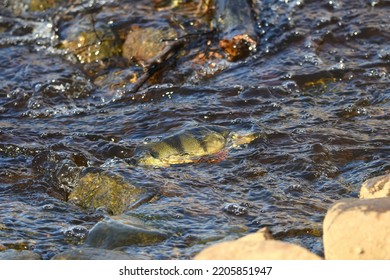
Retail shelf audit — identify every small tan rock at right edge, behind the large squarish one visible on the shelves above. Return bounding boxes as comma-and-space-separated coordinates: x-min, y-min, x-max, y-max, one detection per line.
359, 173, 390, 198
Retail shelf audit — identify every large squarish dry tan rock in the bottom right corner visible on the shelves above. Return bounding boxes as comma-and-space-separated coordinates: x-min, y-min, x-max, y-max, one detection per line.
323, 198, 390, 260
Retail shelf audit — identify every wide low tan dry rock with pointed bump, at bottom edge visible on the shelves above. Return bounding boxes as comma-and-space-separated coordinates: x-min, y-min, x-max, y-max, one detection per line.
195, 229, 321, 260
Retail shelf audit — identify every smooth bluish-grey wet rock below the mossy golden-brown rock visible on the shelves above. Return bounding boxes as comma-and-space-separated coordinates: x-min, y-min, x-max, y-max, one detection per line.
85, 217, 168, 249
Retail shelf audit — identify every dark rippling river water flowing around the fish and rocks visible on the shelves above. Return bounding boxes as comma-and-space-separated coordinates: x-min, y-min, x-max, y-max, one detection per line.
0, 0, 390, 259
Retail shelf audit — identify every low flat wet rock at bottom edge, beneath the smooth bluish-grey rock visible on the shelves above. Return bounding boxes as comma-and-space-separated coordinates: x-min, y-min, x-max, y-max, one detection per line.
52, 248, 142, 260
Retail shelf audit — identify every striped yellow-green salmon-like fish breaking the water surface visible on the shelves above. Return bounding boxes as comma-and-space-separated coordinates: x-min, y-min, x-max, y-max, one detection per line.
137, 125, 258, 167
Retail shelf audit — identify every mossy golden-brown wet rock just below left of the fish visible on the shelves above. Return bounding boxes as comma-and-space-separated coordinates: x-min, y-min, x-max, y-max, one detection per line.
69, 169, 153, 215
